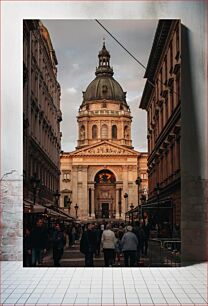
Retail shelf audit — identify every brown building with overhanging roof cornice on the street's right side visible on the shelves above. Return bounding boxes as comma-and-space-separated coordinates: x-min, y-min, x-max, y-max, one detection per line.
140, 20, 181, 223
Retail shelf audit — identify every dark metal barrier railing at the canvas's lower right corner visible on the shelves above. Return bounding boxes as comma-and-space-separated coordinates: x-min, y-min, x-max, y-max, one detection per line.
149, 238, 181, 267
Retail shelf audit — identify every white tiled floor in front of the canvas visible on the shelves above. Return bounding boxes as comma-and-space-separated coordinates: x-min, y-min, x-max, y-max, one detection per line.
1, 261, 207, 306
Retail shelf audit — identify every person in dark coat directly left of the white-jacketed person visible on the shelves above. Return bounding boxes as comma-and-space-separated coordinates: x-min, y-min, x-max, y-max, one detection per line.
80, 223, 97, 267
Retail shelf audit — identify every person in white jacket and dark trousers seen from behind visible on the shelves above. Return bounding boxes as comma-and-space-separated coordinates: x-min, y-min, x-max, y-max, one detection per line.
101, 224, 116, 267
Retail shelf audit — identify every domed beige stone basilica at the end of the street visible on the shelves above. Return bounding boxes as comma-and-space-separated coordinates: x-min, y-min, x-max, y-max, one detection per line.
60, 43, 148, 220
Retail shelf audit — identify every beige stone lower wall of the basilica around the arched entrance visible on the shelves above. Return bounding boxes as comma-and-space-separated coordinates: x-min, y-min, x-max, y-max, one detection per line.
60, 146, 142, 219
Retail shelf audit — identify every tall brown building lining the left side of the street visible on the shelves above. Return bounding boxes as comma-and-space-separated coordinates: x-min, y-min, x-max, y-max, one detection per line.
23, 20, 62, 212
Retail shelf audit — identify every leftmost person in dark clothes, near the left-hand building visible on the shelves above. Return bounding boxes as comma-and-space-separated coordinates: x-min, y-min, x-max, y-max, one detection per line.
31, 218, 48, 267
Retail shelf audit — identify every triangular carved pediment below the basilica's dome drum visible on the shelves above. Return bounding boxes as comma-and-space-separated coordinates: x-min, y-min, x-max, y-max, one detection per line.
70, 141, 139, 156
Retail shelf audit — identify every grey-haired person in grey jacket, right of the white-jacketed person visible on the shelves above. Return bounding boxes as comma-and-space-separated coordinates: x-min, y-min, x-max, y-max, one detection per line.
121, 225, 138, 267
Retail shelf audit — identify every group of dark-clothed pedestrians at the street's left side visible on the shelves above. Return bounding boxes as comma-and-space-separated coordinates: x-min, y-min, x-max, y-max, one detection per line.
23, 217, 81, 267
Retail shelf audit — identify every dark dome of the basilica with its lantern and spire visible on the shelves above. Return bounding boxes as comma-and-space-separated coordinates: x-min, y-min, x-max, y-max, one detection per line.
83, 43, 126, 102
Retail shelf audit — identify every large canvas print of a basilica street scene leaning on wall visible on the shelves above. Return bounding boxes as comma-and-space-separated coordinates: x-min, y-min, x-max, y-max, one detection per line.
23, 19, 181, 267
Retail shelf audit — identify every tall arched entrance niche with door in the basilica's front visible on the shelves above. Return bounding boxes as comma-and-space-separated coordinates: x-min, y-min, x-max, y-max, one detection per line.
95, 169, 116, 219
